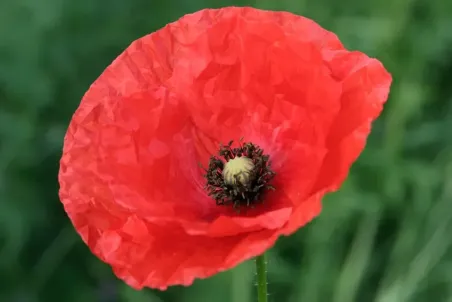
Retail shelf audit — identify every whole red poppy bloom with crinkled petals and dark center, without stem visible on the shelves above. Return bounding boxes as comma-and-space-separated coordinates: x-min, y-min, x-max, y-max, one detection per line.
59, 7, 391, 289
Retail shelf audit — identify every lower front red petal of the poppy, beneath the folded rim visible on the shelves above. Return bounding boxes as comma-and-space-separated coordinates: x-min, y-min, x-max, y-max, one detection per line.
101, 219, 278, 290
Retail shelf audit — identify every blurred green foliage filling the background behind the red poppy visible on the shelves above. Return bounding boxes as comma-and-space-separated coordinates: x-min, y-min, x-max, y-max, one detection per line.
0, 0, 452, 302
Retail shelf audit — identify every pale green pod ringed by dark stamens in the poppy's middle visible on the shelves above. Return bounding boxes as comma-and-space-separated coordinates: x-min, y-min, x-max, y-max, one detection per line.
204, 140, 275, 209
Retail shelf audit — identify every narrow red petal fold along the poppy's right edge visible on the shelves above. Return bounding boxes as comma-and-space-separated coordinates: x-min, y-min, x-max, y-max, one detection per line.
314, 51, 392, 192
